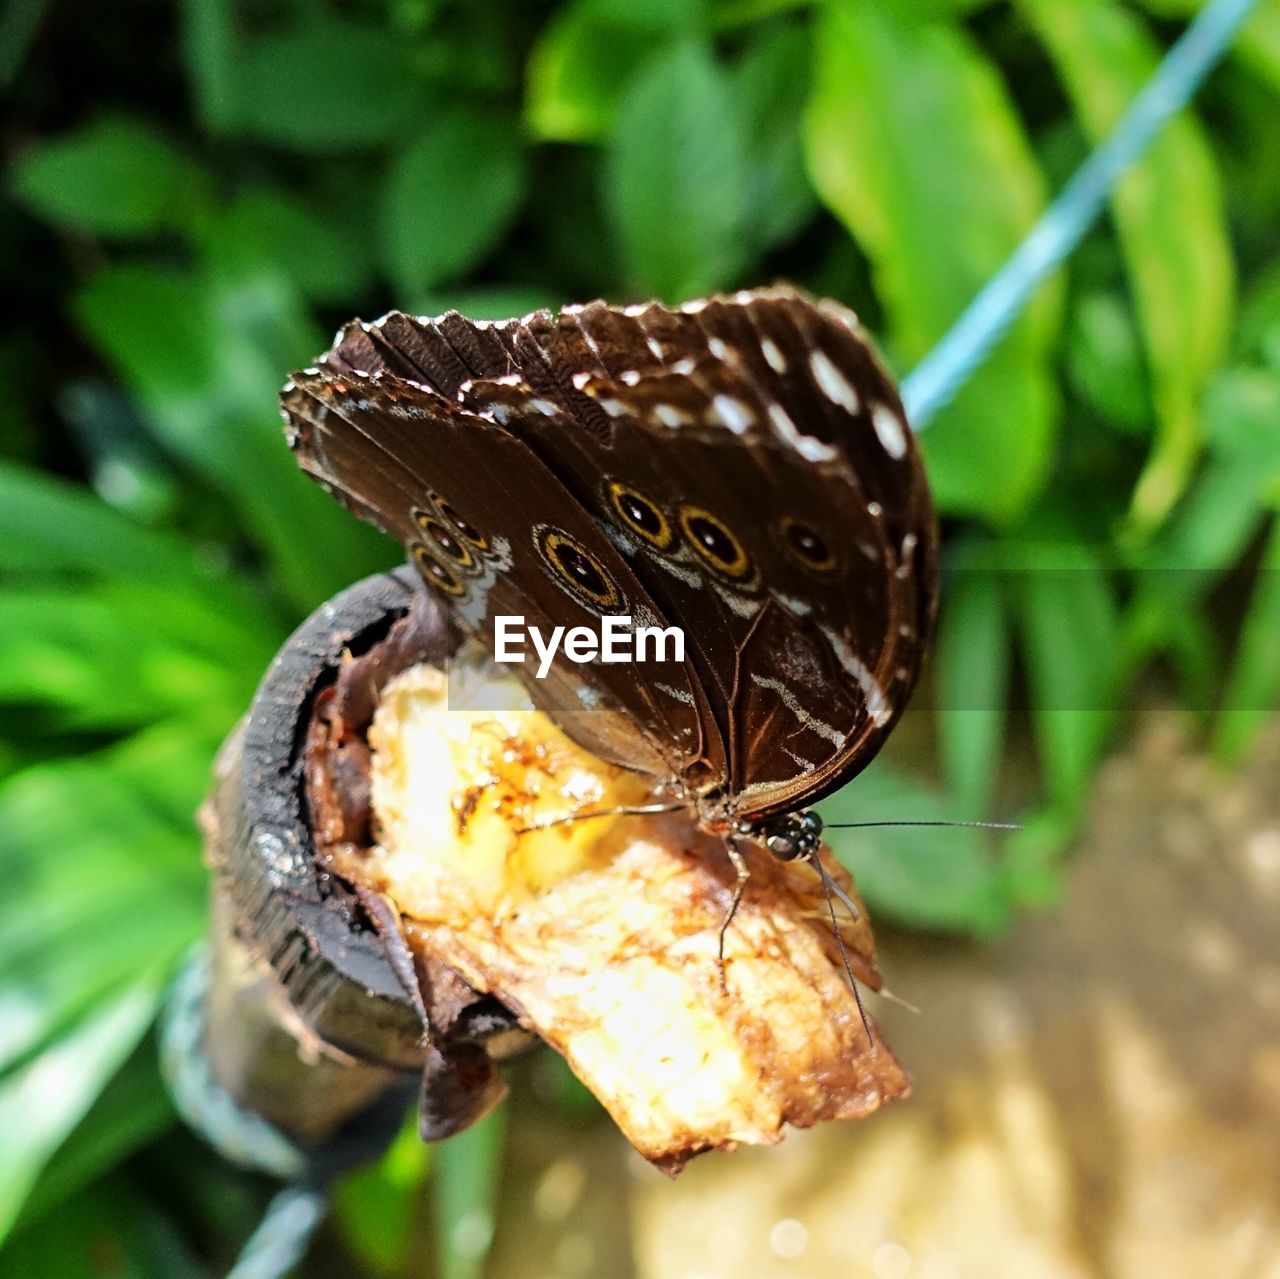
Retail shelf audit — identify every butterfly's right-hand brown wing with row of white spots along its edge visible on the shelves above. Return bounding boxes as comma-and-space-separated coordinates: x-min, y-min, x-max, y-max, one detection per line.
445, 291, 937, 818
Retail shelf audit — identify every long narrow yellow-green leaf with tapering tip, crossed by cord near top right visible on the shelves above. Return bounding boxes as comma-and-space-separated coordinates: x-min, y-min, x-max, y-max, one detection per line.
1020, 0, 1234, 535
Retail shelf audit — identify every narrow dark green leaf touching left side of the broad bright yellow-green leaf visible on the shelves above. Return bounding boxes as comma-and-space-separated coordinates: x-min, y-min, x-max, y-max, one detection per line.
733, 27, 818, 252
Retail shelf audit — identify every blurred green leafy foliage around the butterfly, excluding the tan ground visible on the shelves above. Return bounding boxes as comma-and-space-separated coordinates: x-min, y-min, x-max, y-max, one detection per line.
0, 0, 1280, 1276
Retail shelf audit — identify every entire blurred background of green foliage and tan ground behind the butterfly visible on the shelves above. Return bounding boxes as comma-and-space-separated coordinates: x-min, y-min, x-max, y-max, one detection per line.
0, 0, 1280, 1279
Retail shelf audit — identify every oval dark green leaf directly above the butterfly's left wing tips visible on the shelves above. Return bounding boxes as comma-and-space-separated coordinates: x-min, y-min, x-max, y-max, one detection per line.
381, 110, 525, 294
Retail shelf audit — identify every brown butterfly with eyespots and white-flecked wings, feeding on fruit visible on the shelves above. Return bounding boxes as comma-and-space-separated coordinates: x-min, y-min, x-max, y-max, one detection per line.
280, 287, 938, 973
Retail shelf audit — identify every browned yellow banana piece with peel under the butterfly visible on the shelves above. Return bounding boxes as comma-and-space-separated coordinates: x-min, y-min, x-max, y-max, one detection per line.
328, 664, 910, 1173
